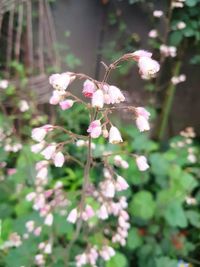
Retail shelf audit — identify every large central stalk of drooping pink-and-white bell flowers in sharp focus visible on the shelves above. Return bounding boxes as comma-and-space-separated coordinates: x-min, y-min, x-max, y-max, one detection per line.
26, 50, 156, 266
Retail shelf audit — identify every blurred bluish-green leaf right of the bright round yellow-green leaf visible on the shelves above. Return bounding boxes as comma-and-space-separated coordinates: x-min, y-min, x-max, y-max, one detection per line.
164, 202, 188, 228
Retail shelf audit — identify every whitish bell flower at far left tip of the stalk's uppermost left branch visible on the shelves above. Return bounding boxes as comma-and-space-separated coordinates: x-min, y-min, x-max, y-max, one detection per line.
49, 73, 71, 90
